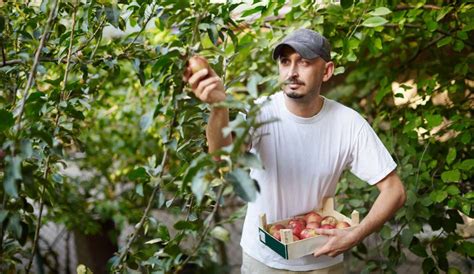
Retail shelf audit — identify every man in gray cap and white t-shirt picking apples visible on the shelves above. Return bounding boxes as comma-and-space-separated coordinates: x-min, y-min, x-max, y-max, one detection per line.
183, 29, 406, 273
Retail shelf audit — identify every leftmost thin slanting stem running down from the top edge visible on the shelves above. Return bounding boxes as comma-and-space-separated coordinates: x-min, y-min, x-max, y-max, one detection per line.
16, 0, 61, 135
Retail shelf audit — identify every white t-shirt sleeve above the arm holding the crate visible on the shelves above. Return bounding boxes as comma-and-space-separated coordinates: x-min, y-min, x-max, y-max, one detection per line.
348, 120, 397, 185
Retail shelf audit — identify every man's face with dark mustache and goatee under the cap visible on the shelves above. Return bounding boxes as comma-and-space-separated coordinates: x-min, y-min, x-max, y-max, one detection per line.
278, 47, 332, 99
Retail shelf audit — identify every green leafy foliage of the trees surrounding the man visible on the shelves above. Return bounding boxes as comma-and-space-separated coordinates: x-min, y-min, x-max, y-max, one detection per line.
0, 0, 474, 273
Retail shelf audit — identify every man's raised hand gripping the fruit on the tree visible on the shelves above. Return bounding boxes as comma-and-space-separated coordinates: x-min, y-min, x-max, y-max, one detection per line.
183, 57, 226, 104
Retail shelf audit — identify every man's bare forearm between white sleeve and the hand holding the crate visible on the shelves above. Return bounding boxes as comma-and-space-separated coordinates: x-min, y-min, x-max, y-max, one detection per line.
353, 173, 406, 242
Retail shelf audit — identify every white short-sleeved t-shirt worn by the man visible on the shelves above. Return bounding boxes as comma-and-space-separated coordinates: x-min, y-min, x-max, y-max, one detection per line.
240, 92, 396, 271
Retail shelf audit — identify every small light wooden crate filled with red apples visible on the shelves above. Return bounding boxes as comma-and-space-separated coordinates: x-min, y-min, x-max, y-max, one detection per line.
258, 197, 359, 260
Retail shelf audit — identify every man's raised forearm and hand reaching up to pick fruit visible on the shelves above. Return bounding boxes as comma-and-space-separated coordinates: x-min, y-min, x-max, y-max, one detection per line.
184, 57, 232, 153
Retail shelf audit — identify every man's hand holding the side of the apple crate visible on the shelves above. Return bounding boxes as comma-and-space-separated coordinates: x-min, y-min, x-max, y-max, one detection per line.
313, 228, 358, 257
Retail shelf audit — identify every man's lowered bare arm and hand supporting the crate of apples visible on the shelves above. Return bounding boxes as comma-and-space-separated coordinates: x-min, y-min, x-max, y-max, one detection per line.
314, 171, 406, 257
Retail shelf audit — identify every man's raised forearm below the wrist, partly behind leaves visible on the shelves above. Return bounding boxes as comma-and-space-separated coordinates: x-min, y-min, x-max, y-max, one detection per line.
206, 108, 232, 153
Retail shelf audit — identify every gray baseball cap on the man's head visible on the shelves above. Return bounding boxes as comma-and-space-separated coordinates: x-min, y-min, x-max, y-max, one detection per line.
273, 28, 331, 62
